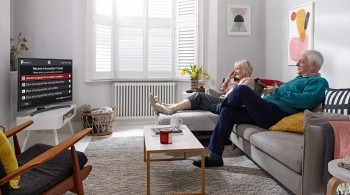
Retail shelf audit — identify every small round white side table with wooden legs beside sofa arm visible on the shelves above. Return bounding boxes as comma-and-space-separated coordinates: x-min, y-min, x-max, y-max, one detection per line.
327, 159, 350, 195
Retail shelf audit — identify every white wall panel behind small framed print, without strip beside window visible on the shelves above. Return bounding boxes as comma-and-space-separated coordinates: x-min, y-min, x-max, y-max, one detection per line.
213, 0, 265, 87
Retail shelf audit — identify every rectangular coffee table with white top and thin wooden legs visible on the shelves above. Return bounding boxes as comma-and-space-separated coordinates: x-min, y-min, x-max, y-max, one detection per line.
144, 125, 205, 194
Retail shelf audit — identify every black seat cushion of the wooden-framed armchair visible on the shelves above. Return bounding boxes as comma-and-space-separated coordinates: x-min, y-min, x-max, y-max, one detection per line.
11, 144, 87, 194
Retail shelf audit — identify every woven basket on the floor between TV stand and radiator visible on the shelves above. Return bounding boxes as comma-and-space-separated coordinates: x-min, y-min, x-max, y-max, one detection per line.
80, 106, 117, 135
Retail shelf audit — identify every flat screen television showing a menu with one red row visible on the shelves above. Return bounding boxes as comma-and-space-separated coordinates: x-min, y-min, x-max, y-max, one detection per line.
17, 58, 73, 115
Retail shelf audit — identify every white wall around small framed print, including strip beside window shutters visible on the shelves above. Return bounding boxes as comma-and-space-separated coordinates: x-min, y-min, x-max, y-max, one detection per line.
204, 0, 265, 89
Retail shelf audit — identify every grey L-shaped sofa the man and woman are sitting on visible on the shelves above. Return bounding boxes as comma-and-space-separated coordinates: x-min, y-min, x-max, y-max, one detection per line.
157, 110, 350, 195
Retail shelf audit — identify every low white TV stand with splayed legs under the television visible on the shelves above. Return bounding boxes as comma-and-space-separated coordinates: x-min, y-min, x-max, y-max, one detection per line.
16, 104, 76, 152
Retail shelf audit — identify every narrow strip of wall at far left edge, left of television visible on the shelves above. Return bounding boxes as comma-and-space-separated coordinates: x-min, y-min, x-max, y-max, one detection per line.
0, 0, 11, 128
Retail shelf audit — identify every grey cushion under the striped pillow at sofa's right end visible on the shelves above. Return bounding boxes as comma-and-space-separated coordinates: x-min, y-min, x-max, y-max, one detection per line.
304, 110, 350, 127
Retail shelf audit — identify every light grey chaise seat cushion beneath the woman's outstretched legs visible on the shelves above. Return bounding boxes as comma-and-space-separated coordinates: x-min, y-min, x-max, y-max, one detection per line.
157, 110, 219, 131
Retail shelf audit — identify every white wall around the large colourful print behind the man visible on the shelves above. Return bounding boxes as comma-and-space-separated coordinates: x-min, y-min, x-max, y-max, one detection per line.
265, 0, 350, 88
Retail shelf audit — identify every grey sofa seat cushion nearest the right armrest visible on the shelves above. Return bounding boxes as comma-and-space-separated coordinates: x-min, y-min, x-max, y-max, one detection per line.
250, 131, 304, 174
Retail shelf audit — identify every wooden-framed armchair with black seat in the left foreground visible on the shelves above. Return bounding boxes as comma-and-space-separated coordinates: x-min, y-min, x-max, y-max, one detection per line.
0, 121, 92, 195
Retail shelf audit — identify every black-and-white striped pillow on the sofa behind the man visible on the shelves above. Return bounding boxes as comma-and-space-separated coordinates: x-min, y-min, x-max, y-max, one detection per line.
324, 88, 350, 115
